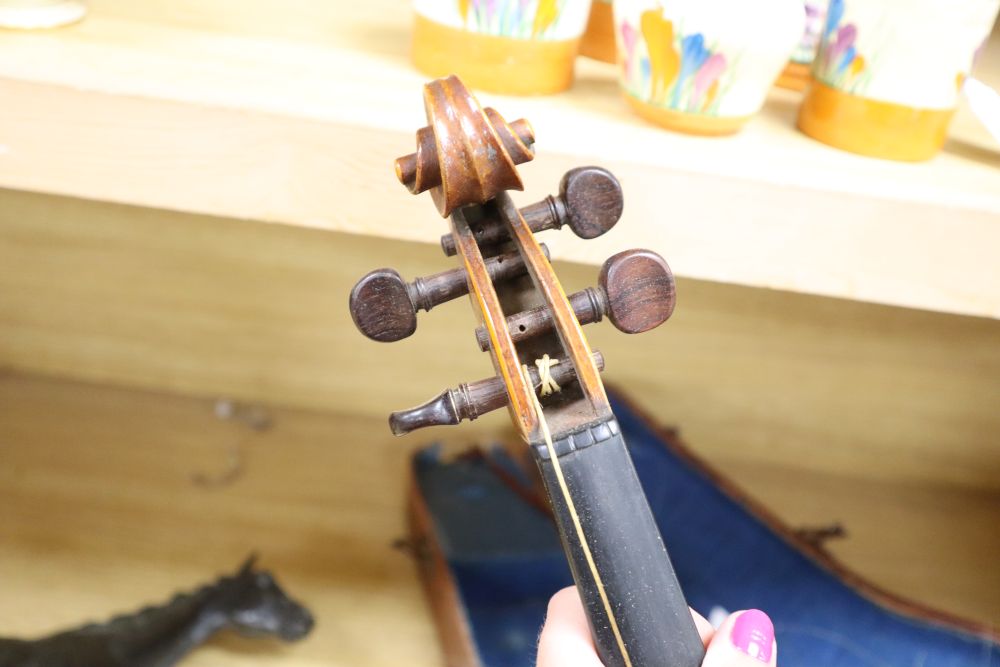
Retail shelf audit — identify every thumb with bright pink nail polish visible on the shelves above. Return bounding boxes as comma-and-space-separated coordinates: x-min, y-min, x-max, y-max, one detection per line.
702, 609, 778, 667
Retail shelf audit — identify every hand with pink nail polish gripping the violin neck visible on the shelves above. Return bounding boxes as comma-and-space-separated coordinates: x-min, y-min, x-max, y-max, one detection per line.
536, 586, 778, 667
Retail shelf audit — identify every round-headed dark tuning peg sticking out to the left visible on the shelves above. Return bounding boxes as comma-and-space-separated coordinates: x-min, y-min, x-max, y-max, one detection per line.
350, 244, 549, 343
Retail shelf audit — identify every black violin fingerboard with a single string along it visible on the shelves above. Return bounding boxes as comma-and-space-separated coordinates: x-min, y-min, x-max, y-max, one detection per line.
532, 417, 705, 667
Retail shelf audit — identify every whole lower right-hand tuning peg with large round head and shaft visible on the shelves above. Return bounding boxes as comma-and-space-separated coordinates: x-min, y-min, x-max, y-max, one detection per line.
476, 250, 676, 352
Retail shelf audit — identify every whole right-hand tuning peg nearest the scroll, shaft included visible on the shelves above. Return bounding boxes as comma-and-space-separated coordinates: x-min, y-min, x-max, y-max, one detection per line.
441, 167, 625, 257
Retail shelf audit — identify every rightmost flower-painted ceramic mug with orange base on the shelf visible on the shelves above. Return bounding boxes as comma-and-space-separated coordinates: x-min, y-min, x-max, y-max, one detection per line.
798, 0, 1000, 160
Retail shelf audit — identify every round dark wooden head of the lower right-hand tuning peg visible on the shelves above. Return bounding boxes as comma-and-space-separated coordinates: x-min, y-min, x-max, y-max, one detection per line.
599, 250, 676, 333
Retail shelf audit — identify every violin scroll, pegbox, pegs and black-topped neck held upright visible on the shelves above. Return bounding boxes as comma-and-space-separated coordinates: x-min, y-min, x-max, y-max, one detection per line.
350, 76, 705, 667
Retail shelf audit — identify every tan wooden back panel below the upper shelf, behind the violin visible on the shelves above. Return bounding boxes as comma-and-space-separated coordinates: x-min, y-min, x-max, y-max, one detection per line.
0, 191, 1000, 489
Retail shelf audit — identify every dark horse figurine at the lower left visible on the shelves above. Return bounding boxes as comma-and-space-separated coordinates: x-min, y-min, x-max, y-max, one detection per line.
0, 557, 313, 667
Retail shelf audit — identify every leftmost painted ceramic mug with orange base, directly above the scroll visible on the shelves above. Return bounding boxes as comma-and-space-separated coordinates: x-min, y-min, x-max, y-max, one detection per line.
412, 0, 591, 95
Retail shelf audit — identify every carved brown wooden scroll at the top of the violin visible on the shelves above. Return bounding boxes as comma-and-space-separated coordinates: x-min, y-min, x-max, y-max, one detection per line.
396, 76, 535, 217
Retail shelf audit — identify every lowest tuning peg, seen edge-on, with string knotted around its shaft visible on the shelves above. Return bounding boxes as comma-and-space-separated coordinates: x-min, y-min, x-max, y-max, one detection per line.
389, 350, 604, 435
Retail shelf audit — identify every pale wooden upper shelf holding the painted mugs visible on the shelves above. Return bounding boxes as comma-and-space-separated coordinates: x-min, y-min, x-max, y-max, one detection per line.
0, 0, 1000, 318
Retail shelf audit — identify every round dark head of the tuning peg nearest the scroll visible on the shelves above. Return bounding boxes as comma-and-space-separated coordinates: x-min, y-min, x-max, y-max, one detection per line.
559, 167, 625, 239
